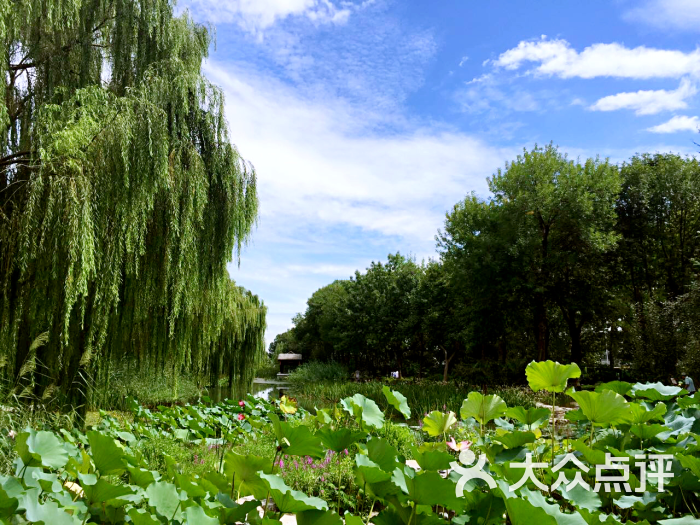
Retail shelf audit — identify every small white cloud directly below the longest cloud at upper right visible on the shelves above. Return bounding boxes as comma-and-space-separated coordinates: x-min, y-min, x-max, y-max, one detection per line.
589, 79, 698, 115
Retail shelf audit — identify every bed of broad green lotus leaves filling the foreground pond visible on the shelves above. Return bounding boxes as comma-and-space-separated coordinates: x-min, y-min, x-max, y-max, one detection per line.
0, 361, 700, 525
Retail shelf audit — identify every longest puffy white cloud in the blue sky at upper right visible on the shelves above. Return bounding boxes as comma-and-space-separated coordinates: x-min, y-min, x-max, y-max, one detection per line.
490, 36, 700, 79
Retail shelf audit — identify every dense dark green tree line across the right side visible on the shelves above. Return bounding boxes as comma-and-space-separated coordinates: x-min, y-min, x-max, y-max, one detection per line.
271, 145, 700, 382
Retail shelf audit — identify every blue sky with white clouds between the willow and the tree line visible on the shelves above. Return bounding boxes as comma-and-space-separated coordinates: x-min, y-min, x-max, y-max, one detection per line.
179, 0, 700, 343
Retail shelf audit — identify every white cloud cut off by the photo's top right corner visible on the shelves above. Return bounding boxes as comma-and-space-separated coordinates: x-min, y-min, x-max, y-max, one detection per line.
623, 0, 700, 31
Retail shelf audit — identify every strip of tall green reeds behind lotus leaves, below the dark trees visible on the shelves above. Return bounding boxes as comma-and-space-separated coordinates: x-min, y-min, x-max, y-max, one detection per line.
291, 381, 535, 417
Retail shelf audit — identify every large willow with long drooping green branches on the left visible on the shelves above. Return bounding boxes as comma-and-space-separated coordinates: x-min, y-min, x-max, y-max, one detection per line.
0, 0, 265, 402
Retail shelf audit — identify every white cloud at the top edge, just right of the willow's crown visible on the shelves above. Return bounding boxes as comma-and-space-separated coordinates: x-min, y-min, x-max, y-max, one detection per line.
179, 0, 361, 32
